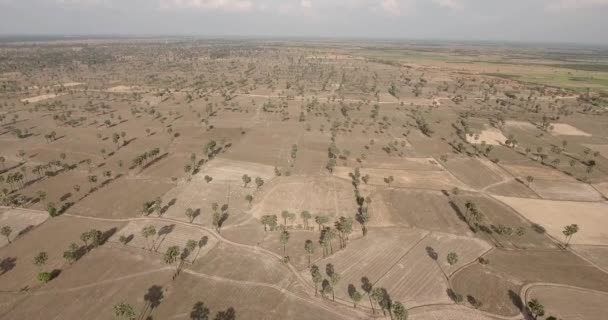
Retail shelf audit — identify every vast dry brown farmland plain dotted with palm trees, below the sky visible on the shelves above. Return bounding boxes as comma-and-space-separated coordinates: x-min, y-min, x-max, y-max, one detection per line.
0, 39, 608, 320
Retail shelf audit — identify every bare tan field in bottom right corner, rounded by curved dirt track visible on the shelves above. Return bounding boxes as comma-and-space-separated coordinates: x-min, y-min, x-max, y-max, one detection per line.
526, 285, 608, 320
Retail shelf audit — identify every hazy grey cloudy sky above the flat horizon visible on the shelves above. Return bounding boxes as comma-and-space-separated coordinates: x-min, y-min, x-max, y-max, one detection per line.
0, 0, 608, 44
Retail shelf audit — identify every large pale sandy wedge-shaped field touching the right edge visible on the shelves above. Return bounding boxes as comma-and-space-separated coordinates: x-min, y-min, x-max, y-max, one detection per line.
494, 196, 608, 245
